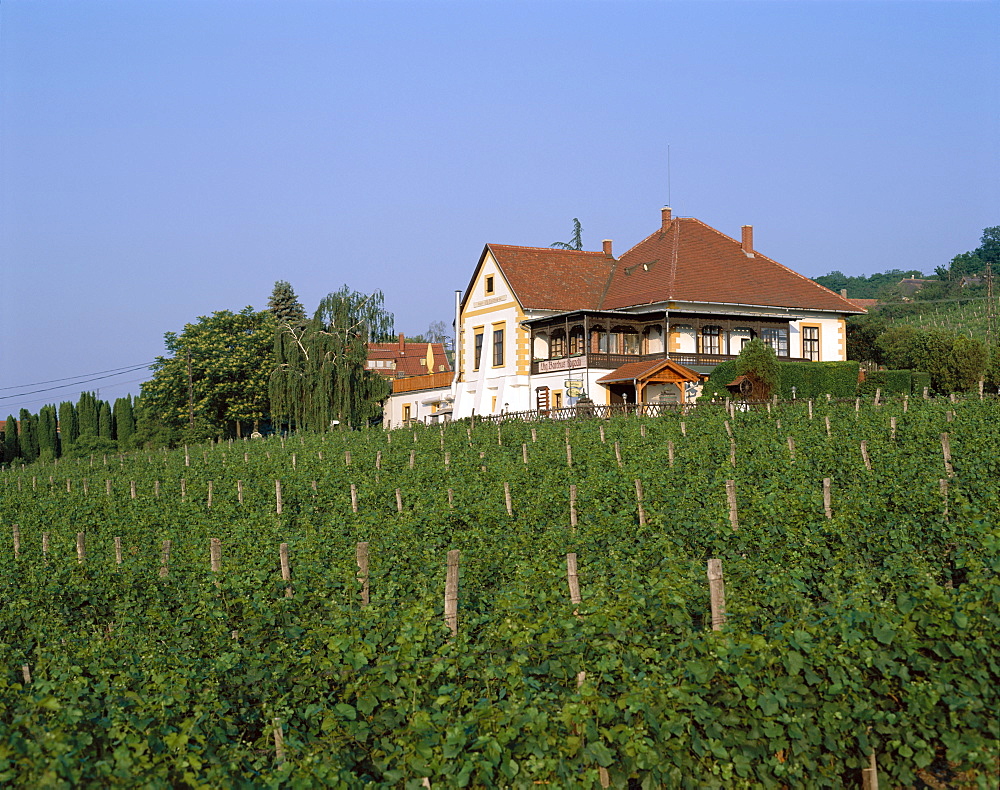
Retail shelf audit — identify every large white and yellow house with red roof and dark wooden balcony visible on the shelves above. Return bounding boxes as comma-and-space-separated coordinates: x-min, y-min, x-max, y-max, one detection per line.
453, 208, 865, 418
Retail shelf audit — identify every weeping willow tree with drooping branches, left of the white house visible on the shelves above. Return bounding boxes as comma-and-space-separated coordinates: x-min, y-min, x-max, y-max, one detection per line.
269, 285, 393, 431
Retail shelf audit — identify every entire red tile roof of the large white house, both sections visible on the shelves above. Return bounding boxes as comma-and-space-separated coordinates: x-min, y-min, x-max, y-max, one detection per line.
476, 217, 864, 313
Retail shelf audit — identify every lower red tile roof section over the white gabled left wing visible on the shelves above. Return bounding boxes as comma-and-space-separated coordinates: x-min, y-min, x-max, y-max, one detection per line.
486, 244, 615, 310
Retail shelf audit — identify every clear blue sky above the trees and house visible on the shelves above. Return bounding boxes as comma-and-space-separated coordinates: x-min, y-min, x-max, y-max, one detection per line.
0, 0, 1000, 418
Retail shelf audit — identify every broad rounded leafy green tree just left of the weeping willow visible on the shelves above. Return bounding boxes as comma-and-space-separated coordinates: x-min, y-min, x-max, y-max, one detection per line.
141, 307, 275, 441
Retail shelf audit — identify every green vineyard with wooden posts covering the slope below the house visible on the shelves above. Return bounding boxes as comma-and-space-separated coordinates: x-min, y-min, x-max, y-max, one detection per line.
0, 397, 1000, 790
